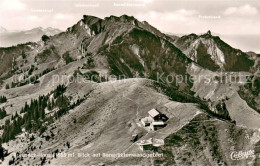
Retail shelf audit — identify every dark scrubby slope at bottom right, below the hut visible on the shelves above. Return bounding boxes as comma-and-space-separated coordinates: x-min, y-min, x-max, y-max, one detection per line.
156, 114, 255, 165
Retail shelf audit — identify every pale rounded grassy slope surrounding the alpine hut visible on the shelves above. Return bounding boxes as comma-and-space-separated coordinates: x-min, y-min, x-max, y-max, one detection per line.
1, 79, 203, 164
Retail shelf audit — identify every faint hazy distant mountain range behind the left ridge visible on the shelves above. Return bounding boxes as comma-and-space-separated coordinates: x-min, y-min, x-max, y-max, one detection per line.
0, 26, 61, 47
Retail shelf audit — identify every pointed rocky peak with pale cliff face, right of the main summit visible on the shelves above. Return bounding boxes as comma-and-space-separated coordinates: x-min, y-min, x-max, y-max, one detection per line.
175, 31, 254, 71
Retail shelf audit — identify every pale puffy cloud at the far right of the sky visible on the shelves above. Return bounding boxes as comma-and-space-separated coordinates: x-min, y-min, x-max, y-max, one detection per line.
224, 4, 258, 16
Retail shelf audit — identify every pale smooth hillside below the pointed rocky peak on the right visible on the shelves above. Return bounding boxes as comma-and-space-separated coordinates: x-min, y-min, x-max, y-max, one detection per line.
188, 64, 260, 129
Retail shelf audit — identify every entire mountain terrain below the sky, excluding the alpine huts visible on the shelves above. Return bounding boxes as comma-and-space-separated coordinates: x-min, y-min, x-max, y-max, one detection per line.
0, 15, 260, 165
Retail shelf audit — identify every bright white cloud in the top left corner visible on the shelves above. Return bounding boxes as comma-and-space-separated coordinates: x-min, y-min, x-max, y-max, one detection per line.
0, 0, 26, 11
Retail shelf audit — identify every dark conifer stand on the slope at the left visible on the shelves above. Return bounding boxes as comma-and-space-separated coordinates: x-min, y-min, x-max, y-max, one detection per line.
1, 85, 70, 142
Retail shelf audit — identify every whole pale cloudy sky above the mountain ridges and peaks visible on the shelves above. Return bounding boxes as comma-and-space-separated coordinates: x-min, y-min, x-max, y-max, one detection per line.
0, 0, 260, 35
